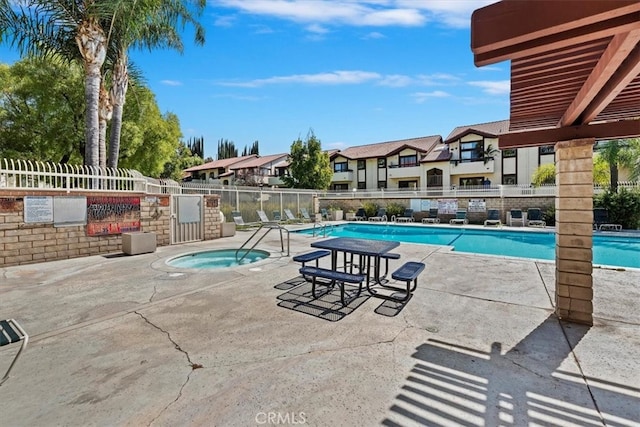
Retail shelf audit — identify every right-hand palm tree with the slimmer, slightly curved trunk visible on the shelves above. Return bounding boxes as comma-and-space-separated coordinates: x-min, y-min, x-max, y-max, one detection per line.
108, 0, 206, 168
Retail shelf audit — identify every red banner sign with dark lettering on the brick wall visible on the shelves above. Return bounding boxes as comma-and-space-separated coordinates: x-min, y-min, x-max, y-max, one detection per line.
87, 196, 140, 236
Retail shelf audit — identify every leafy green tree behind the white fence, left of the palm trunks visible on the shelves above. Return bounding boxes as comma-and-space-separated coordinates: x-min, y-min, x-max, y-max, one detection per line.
0, 58, 84, 163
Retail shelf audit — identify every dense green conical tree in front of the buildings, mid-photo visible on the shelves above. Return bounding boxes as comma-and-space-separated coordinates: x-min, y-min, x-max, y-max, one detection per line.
282, 131, 333, 190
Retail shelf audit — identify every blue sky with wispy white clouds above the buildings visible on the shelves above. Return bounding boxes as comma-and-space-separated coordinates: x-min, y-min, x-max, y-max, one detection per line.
0, 0, 509, 158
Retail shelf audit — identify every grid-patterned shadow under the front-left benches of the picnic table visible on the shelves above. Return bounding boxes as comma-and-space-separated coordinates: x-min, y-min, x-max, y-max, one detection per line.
275, 277, 369, 322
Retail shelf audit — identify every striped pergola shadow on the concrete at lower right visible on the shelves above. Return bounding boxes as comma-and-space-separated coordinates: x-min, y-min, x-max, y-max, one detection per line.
382, 316, 640, 426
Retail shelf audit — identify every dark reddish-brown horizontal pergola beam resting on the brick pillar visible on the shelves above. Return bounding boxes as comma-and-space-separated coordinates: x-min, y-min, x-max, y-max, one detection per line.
498, 119, 640, 149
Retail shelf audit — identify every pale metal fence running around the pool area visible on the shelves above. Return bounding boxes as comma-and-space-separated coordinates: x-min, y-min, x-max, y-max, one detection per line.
0, 159, 640, 222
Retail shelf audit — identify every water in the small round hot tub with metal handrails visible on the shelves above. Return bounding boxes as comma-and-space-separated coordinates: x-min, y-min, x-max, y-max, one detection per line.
167, 249, 269, 268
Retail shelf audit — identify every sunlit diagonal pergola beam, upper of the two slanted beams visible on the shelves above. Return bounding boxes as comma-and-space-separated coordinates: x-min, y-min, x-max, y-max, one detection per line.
558, 30, 640, 127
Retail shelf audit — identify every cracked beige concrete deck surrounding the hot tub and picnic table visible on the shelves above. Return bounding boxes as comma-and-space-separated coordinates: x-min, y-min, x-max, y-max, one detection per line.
0, 232, 640, 426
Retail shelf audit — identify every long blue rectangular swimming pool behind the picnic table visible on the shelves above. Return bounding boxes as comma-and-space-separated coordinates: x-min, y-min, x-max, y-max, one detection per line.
298, 223, 640, 268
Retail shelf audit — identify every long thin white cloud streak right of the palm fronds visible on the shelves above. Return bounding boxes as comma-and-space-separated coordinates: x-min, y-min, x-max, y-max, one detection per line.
221, 71, 381, 87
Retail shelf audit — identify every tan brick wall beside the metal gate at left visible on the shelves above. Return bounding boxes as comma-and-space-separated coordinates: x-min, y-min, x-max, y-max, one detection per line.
0, 191, 221, 267
